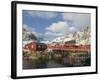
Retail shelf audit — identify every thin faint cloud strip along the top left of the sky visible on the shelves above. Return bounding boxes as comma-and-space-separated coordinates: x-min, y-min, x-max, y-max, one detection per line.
27, 11, 57, 19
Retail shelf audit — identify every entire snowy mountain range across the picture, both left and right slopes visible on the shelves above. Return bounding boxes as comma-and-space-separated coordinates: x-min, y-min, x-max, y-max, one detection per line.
23, 27, 91, 46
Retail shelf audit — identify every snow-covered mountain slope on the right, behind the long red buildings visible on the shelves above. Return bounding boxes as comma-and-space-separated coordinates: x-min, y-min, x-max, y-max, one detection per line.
52, 27, 91, 45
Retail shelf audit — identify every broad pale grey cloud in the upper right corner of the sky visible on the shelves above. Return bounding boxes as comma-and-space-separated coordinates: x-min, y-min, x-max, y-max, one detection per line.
62, 13, 91, 29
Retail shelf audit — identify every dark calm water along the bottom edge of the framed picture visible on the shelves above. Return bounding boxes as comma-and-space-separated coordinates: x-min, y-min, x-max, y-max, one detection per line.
23, 59, 90, 69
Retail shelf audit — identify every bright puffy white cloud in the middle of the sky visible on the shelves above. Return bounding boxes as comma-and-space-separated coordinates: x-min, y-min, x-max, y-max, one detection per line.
45, 21, 76, 37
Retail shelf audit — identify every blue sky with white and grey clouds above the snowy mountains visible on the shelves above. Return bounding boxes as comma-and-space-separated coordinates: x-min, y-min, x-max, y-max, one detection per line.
23, 10, 91, 40
